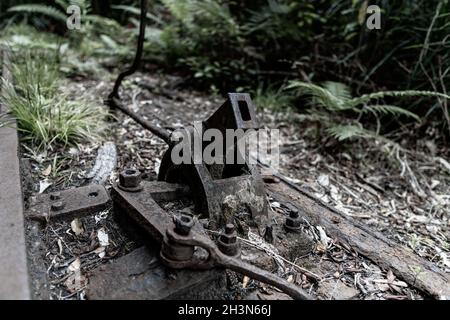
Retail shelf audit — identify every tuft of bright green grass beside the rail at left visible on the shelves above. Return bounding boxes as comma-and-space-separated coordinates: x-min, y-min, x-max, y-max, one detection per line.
0, 51, 106, 149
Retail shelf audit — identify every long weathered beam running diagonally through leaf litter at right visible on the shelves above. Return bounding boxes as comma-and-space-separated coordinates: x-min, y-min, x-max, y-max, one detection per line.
266, 177, 450, 299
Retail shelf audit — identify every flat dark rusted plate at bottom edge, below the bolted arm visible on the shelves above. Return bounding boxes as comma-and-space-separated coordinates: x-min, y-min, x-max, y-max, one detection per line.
86, 247, 226, 300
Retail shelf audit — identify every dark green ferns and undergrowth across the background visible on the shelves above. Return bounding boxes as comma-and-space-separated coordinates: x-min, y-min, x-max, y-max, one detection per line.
0, 0, 450, 138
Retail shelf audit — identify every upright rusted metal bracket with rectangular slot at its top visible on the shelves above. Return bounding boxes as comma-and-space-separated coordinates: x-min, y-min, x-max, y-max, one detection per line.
158, 93, 267, 227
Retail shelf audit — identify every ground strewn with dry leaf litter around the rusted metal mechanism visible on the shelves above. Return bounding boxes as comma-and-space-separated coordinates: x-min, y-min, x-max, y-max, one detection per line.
23, 67, 450, 299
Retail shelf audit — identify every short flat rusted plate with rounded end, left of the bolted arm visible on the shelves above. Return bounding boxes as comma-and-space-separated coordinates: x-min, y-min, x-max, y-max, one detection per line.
26, 184, 111, 220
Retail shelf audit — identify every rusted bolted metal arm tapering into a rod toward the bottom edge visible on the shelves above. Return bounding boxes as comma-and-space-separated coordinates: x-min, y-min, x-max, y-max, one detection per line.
111, 178, 312, 299
